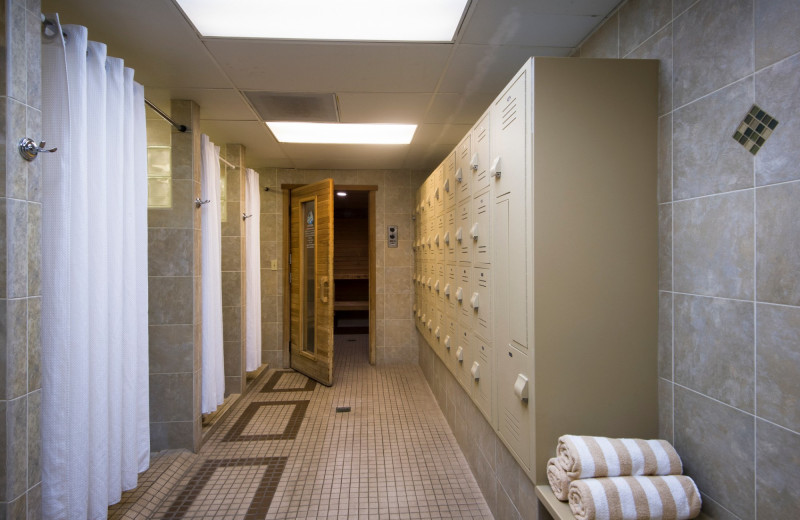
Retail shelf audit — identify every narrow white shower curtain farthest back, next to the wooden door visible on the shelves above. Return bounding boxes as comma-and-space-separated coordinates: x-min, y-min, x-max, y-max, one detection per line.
244, 168, 261, 372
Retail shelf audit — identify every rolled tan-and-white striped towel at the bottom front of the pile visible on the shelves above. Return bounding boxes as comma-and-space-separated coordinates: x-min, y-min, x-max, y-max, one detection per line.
569, 475, 702, 520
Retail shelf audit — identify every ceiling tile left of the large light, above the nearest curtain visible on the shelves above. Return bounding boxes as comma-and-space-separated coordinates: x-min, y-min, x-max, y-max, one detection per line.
42, 0, 231, 88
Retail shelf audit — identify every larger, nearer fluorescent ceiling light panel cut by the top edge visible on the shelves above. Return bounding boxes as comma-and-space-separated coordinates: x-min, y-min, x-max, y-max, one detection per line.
175, 0, 468, 42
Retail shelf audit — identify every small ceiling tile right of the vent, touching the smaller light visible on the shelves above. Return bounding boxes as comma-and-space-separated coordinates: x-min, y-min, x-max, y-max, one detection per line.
338, 92, 432, 124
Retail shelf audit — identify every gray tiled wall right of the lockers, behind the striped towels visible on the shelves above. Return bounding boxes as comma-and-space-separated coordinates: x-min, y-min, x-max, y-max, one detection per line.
578, 0, 800, 520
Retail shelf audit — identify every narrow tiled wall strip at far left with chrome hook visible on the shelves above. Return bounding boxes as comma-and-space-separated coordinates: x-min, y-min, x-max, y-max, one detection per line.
0, 0, 46, 519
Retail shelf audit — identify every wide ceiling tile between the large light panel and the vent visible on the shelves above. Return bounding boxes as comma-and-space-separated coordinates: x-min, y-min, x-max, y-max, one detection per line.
206, 39, 452, 93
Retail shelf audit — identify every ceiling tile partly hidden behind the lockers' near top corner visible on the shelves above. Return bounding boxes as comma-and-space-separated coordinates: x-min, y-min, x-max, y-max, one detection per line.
439, 45, 570, 95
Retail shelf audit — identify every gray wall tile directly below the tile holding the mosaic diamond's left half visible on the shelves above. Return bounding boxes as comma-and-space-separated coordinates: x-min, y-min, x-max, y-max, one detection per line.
673, 190, 754, 300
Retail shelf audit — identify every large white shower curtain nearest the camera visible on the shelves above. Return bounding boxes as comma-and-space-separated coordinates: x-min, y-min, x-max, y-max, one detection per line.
41, 15, 150, 519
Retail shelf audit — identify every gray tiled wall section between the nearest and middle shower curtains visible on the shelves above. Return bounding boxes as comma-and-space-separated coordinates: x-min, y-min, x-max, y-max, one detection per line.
147, 100, 202, 451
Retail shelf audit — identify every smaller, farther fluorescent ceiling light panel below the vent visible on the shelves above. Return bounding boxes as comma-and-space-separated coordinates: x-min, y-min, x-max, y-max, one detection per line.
267, 122, 417, 144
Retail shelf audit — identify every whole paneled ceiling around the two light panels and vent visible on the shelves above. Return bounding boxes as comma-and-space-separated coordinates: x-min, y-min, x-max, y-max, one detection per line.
42, 0, 620, 170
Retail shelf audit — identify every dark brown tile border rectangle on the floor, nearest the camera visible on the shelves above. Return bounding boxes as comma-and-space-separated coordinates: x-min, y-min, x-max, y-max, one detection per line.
161, 457, 288, 520
